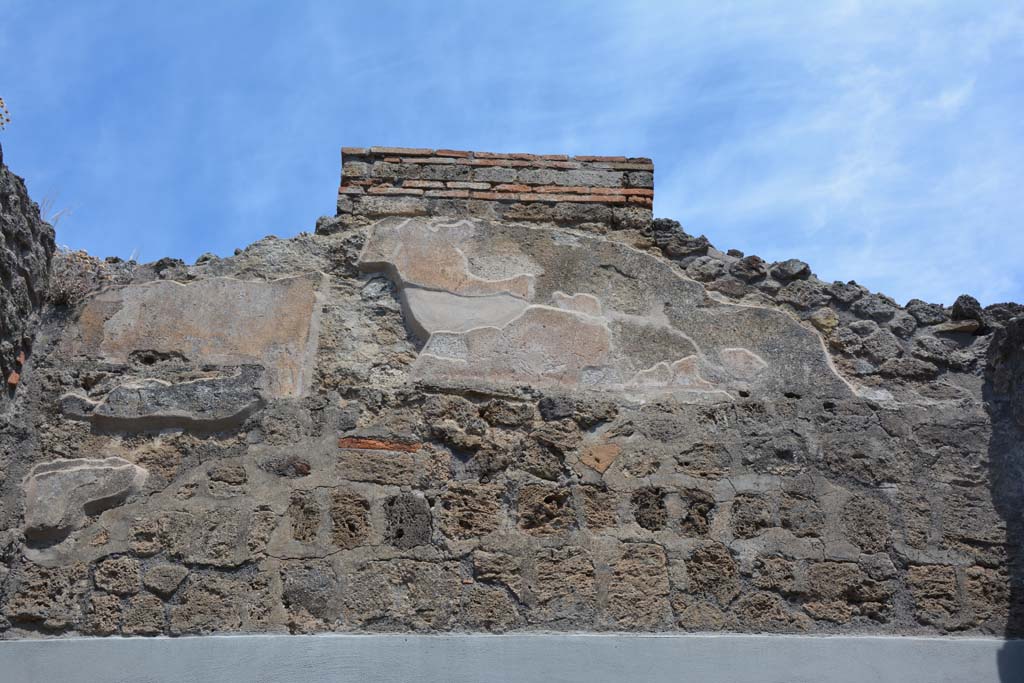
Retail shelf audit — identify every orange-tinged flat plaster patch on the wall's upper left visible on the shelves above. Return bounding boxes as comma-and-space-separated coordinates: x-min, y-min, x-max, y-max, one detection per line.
68, 275, 319, 396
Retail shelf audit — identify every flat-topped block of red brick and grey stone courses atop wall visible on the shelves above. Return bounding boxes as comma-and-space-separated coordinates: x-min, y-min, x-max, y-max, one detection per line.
338, 147, 654, 229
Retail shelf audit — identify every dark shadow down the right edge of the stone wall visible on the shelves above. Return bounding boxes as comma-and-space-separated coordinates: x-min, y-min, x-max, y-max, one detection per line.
983, 317, 1024, 683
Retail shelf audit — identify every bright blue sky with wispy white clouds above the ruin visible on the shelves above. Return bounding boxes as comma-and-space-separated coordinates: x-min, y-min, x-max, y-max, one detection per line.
0, 0, 1024, 304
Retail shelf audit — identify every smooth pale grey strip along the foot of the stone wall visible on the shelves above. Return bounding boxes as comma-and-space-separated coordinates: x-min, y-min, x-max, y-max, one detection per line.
0, 634, 1024, 683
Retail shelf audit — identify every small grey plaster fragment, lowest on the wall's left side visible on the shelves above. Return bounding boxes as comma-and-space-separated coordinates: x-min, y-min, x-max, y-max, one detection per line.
23, 458, 147, 541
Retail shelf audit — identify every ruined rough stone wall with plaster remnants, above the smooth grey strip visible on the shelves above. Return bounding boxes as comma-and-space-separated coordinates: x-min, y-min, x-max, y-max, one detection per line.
0, 145, 1024, 638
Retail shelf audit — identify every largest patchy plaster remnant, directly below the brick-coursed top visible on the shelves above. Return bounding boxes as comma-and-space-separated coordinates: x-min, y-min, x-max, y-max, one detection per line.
360, 219, 849, 398
